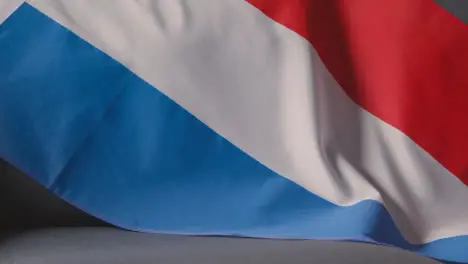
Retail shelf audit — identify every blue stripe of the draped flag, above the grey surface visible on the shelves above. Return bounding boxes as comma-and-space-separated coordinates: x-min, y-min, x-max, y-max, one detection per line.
0, 4, 468, 262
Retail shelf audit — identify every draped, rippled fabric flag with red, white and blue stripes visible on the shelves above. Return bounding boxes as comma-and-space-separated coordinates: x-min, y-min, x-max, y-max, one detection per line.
0, 0, 468, 263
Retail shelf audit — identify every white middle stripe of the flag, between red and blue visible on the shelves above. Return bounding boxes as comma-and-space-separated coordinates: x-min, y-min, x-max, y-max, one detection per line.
29, 0, 468, 243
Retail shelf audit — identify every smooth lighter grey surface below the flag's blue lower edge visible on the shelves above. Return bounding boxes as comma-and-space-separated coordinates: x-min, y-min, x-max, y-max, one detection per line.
0, 227, 437, 264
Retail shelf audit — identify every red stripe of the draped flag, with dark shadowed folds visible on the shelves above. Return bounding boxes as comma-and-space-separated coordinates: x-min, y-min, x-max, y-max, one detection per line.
249, 0, 468, 184
